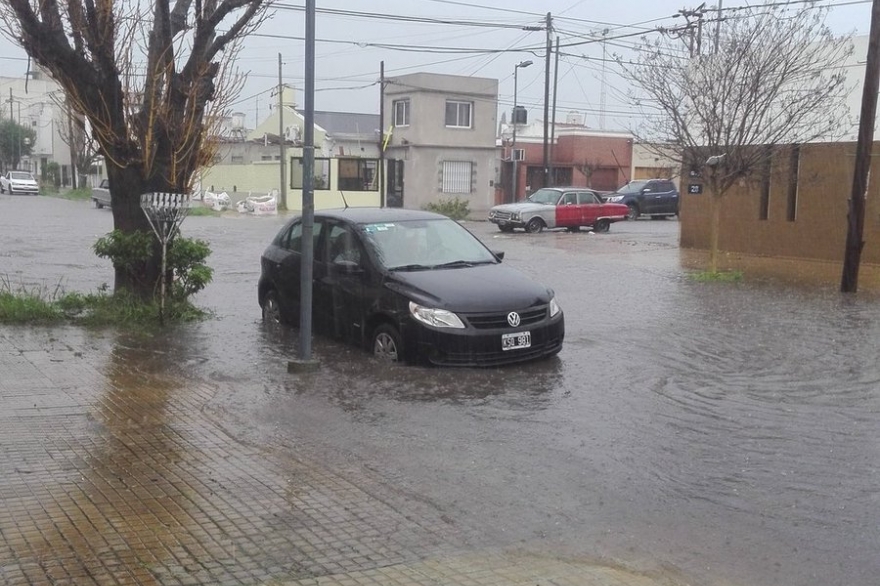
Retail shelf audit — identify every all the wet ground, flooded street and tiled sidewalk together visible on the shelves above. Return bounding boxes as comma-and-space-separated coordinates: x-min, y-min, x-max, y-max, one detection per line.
0, 196, 880, 586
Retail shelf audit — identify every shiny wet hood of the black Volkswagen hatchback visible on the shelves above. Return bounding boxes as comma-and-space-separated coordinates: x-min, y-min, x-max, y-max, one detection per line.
386, 263, 552, 313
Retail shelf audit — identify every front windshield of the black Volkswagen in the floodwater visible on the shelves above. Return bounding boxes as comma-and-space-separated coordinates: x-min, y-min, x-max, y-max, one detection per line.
362, 218, 498, 270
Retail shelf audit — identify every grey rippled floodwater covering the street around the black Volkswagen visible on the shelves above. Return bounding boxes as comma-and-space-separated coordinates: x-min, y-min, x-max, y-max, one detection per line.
0, 196, 880, 586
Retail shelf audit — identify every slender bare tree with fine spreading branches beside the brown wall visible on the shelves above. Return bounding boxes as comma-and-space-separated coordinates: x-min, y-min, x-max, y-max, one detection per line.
620, 2, 852, 272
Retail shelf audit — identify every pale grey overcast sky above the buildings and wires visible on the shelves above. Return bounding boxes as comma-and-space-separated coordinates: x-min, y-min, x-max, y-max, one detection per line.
0, 0, 871, 130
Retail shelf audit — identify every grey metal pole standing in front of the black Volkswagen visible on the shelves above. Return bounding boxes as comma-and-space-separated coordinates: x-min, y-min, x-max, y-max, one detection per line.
298, 0, 315, 368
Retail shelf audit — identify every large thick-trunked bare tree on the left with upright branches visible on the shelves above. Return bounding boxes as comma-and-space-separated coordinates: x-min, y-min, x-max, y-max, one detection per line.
0, 0, 273, 297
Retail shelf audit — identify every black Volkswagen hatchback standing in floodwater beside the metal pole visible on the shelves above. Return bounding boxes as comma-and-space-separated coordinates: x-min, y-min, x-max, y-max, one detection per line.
258, 208, 565, 366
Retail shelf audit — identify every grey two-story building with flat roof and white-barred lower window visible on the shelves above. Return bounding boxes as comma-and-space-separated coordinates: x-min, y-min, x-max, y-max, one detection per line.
383, 73, 498, 217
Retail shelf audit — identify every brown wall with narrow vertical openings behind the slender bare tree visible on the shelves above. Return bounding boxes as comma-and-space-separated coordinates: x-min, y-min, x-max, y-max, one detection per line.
680, 143, 880, 264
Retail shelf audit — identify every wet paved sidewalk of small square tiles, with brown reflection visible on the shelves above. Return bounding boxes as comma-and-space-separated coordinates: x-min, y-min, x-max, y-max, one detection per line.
0, 326, 680, 586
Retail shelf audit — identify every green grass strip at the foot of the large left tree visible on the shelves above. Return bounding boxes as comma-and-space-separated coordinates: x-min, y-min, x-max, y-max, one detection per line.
0, 278, 209, 327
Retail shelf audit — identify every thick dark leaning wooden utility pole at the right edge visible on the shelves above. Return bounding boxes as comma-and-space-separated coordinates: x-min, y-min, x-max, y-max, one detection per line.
840, 0, 880, 293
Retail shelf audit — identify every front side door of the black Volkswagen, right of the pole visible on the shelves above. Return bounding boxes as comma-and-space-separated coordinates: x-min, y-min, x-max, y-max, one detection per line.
316, 222, 369, 341
